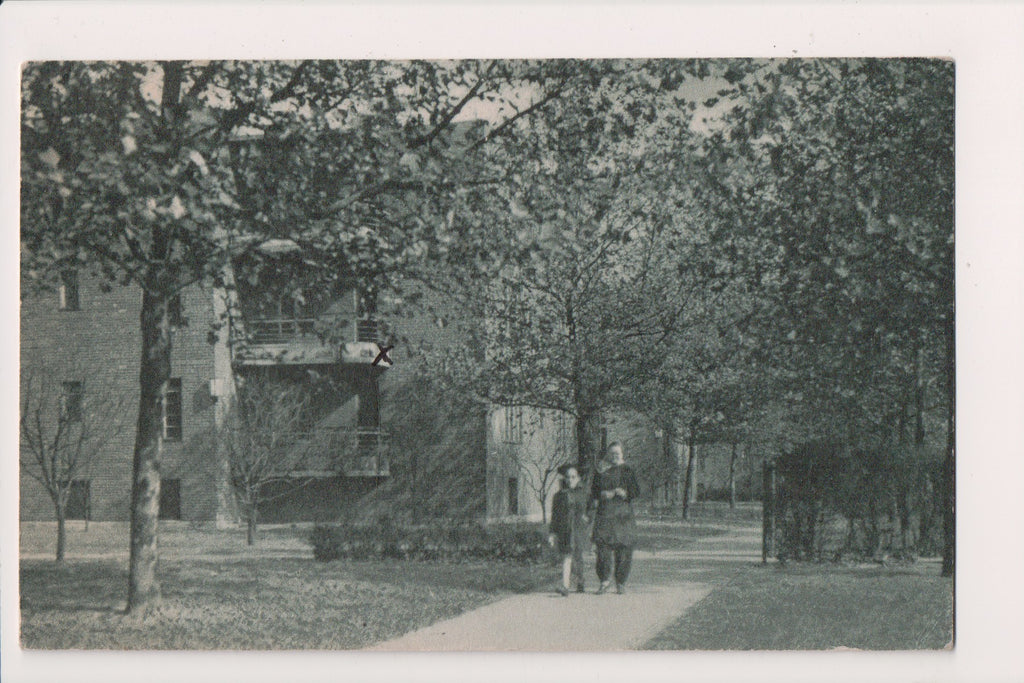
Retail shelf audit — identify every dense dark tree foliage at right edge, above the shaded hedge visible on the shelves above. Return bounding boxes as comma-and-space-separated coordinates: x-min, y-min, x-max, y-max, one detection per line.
700, 59, 955, 572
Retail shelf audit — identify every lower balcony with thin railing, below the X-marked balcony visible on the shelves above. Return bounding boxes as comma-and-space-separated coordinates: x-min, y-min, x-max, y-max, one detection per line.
236, 428, 390, 479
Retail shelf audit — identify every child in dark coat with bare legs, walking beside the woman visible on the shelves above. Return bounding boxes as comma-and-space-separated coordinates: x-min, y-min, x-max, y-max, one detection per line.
548, 465, 590, 596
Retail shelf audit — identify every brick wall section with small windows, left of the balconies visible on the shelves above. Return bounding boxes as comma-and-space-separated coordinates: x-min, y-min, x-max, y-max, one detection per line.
20, 274, 216, 520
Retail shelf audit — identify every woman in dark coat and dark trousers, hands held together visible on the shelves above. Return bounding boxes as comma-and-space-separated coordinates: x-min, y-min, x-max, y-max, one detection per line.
588, 441, 640, 594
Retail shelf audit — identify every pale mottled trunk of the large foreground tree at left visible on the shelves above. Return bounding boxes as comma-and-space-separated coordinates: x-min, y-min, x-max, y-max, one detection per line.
127, 289, 171, 615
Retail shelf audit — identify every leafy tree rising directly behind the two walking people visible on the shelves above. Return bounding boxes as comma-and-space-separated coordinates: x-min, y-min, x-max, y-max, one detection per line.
424, 60, 719, 468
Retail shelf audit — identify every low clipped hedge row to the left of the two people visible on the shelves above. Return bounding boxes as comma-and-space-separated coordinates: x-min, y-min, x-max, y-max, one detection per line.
309, 517, 551, 564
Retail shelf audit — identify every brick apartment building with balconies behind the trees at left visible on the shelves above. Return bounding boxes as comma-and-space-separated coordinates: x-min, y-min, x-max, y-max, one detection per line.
20, 245, 388, 521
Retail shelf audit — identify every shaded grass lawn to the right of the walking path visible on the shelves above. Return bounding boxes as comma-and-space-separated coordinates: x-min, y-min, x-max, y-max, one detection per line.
646, 562, 953, 650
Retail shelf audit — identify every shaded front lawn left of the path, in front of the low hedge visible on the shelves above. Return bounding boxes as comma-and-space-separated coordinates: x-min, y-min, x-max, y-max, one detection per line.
22, 557, 555, 649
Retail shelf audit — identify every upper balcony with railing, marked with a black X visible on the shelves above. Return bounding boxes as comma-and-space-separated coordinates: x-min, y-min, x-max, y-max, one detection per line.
234, 317, 386, 367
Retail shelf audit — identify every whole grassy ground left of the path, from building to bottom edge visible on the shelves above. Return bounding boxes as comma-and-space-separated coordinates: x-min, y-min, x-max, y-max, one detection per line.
20, 522, 715, 649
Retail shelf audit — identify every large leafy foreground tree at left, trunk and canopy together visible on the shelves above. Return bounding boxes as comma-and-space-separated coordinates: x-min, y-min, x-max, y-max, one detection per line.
22, 61, 573, 613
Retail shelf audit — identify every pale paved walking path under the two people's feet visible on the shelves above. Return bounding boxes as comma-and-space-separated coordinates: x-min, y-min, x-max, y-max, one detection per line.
370, 527, 761, 651
